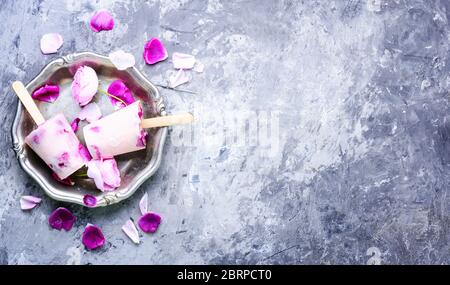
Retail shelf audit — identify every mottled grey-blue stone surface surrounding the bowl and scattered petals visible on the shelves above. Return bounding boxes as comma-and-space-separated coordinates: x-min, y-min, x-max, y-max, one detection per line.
0, 0, 450, 264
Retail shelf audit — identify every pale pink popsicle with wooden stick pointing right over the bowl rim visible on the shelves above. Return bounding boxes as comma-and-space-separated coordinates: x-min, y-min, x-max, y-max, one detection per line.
83, 101, 194, 159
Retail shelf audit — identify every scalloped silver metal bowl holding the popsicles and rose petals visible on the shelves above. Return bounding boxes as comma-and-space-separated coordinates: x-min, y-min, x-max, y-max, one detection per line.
11, 52, 167, 207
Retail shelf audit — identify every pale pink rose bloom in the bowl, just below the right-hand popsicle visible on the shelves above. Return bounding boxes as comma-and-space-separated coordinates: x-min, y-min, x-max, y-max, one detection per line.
87, 158, 120, 192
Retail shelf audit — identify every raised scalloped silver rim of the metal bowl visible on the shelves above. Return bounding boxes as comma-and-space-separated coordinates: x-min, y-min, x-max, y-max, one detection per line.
11, 52, 167, 207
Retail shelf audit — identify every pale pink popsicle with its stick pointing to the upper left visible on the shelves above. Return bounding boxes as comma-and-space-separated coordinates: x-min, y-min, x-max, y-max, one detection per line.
12, 81, 85, 179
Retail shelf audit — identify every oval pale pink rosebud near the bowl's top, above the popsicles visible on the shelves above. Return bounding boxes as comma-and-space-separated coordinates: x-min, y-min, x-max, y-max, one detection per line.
72, 66, 98, 106
